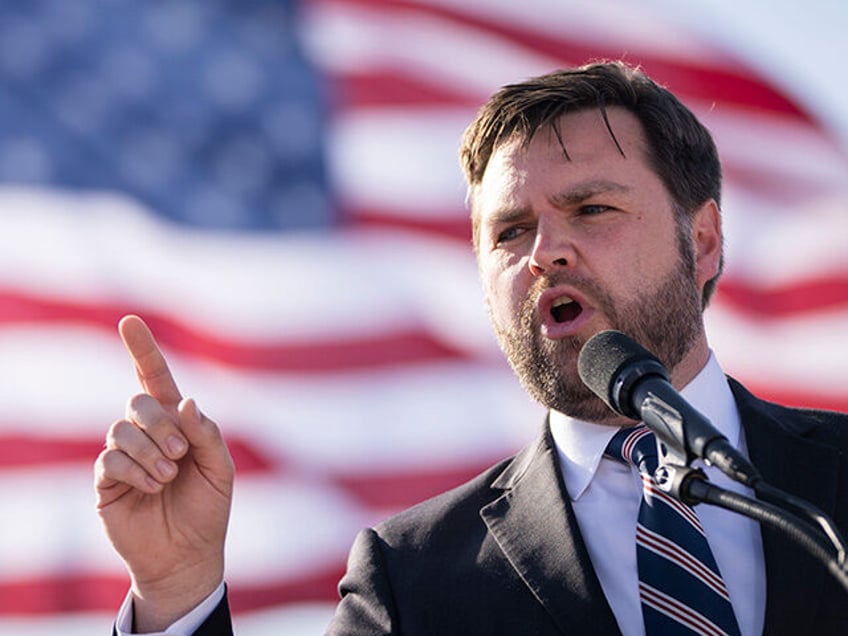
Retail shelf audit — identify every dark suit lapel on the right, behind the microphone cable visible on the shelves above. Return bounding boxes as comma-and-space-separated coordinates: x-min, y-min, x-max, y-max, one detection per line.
730, 380, 839, 634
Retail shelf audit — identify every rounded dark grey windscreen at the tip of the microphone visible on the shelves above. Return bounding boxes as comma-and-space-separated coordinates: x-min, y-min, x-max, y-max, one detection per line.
577, 330, 660, 417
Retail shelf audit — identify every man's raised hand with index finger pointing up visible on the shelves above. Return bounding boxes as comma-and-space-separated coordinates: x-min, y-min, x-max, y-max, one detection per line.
95, 316, 234, 631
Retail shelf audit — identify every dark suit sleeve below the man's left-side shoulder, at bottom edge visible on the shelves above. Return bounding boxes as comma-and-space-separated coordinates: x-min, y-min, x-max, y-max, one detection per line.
326, 528, 399, 636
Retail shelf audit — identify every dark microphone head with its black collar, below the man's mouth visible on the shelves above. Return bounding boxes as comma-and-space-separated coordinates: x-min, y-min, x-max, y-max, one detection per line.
577, 330, 669, 420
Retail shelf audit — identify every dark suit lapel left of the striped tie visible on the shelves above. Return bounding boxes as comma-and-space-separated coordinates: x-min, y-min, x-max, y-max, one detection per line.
480, 427, 618, 634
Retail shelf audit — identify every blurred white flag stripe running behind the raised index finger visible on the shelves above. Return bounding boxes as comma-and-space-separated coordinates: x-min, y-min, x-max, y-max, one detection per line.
0, 326, 544, 472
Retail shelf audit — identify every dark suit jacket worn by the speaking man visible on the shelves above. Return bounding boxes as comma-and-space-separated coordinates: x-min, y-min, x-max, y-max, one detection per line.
179, 380, 848, 636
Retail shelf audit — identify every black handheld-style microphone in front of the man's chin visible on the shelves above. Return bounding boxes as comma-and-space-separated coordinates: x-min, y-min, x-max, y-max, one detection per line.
577, 330, 762, 487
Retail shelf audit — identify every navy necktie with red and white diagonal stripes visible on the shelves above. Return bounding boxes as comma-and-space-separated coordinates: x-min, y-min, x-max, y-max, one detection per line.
606, 426, 739, 636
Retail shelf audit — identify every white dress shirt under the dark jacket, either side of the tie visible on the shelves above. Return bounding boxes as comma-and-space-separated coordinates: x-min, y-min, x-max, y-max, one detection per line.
551, 354, 766, 636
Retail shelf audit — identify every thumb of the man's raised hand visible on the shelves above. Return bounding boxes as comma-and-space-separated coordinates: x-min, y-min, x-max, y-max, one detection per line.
177, 398, 235, 493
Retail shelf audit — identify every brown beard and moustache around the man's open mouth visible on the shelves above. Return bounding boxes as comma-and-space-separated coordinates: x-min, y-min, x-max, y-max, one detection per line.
493, 238, 702, 422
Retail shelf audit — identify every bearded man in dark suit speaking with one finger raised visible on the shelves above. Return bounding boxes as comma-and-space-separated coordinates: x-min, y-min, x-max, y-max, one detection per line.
96, 63, 848, 635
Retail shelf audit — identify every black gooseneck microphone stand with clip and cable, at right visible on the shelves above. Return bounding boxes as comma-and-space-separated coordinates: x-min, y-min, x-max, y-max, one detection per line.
654, 454, 848, 592
